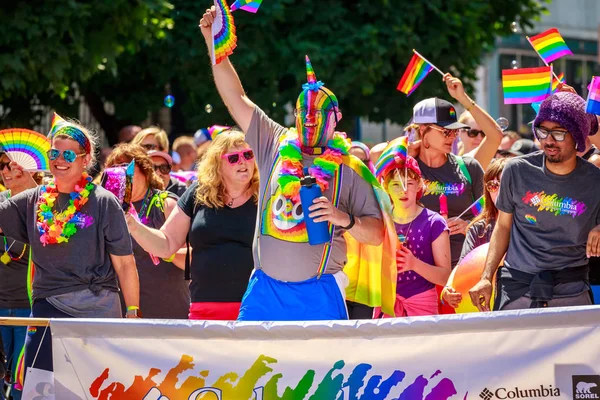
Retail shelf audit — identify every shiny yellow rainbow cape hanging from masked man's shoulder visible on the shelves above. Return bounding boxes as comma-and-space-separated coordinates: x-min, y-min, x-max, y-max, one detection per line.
342, 155, 398, 316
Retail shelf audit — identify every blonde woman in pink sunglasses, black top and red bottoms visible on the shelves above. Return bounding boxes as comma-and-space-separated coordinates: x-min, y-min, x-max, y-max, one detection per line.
126, 131, 258, 320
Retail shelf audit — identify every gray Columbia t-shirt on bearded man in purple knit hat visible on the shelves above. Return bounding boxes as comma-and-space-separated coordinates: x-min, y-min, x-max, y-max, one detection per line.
496, 151, 600, 274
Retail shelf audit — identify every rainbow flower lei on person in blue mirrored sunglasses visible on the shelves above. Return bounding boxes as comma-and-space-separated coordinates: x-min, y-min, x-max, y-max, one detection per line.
37, 172, 96, 246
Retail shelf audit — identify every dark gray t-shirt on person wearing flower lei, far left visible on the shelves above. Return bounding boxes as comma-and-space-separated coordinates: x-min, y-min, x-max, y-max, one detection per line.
0, 186, 132, 299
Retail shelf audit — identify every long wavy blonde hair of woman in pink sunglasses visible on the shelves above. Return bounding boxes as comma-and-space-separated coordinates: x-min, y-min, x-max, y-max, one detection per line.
195, 130, 258, 208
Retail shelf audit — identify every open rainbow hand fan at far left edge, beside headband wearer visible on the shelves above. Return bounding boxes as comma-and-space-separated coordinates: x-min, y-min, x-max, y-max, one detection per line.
0, 128, 50, 172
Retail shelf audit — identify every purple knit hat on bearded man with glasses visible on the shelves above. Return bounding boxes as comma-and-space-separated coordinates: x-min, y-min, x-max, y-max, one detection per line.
533, 92, 598, 152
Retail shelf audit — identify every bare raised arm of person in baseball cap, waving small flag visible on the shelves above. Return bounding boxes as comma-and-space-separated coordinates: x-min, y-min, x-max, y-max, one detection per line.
444, 74, 502, 171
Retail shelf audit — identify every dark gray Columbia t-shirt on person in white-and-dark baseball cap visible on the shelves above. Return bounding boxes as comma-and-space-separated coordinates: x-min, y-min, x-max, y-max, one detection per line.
417, 154, 483, 266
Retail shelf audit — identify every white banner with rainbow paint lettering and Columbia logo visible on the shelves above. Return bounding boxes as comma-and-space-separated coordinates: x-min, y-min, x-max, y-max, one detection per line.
51, 306, 600, 400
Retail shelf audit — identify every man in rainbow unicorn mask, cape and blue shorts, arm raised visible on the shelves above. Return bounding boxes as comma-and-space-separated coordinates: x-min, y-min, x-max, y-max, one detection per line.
200, 7, 396, 321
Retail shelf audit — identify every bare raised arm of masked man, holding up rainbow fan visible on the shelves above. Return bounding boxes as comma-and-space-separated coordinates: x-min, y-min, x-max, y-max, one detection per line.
200, 6, 256, 132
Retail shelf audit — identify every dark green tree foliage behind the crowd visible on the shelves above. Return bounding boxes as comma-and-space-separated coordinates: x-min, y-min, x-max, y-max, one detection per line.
0, 0, 544, 144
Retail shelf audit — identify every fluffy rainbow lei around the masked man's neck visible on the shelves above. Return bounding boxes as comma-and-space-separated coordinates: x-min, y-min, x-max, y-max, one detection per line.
277, 128, 350, 201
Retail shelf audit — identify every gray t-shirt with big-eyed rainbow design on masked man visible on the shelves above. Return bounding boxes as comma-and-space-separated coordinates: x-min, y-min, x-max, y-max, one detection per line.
246, 107, 383, 282
